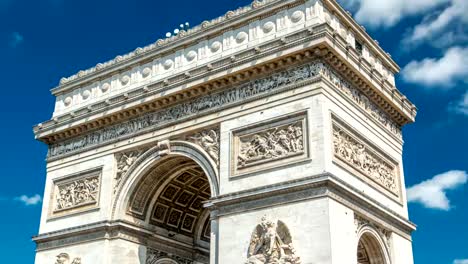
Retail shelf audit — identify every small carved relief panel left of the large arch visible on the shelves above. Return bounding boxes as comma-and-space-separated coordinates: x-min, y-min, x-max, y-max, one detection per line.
55, 177, 99, 210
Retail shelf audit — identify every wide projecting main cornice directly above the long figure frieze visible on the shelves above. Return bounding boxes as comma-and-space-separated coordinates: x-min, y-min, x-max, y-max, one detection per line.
34, 24, 416, 148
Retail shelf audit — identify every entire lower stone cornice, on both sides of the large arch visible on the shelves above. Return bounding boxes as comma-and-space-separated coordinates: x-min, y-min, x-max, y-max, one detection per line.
33, 173, 416, 250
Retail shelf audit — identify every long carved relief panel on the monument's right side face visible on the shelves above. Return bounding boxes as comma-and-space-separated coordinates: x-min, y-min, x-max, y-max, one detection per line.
333, 128, 397, 191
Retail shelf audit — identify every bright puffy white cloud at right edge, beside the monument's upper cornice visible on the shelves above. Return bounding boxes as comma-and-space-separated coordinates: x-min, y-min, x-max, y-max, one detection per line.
402, 47, 468, 88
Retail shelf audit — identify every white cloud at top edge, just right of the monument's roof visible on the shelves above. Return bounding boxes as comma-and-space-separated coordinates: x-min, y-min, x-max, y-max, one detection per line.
339, 0, 452, 28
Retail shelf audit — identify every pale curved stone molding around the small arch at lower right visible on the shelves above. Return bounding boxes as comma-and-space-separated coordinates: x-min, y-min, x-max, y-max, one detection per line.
355, 225, 392, 264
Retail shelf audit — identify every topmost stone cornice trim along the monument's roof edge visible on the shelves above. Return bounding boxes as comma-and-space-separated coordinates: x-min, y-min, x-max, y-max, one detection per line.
51, 0, 399, 95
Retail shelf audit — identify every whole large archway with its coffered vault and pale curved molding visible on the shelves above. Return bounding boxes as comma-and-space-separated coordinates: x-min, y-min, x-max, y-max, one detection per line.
114, 142, 217, 264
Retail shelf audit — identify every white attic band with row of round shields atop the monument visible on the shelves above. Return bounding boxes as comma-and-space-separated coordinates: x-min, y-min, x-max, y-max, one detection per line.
43, 0, 408, 117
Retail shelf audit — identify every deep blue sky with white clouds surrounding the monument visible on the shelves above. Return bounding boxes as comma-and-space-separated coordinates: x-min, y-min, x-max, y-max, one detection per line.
0, 0, 468, 264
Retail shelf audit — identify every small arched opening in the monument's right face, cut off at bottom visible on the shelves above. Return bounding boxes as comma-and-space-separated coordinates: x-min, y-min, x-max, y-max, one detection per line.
357, 230, 390, 264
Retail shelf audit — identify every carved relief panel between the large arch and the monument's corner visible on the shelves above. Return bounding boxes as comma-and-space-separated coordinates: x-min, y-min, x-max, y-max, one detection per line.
238, 124, 304, 166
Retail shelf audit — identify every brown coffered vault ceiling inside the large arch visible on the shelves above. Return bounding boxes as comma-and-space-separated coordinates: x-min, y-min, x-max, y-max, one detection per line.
127, 156, 211, 242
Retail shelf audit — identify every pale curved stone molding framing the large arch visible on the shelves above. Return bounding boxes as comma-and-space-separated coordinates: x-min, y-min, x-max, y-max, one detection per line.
112, 141, 219, 220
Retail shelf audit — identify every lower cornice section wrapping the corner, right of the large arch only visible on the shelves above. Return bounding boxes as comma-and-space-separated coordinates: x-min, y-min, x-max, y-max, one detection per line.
205, 172, 416, 235
